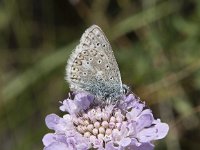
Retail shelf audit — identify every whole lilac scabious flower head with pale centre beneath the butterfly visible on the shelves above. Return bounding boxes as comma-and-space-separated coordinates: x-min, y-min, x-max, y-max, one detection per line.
43, 93, 169, 150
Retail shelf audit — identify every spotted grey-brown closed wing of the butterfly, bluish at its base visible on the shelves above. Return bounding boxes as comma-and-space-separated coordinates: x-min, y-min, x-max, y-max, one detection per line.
66, 25, 123, 97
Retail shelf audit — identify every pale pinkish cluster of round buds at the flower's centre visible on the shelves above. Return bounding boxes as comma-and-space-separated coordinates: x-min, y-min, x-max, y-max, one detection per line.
73, 107, 127, 140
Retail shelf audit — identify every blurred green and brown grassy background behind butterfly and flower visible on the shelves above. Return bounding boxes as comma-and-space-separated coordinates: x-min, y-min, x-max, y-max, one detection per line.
0, 0, 200, 150
